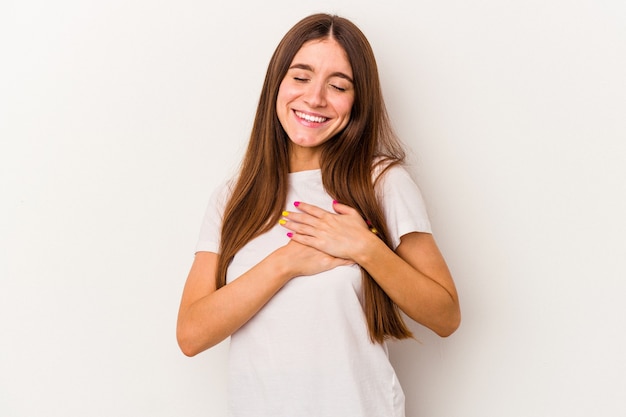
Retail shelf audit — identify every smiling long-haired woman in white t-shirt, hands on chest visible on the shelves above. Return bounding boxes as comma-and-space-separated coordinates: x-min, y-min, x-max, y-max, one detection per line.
177, 14, 460, 417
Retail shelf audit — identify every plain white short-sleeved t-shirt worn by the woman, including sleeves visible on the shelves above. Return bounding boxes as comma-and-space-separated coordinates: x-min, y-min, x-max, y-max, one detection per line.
196, 166, 431, 417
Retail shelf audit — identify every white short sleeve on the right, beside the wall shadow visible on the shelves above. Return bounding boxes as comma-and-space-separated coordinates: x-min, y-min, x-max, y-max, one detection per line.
376, 165, 432, 250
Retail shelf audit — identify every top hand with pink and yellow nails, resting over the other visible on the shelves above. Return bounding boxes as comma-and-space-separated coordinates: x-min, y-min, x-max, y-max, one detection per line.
281, 202, 375, 262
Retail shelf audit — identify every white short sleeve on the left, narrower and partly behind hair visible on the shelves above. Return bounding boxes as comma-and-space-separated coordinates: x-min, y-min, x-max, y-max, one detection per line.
196, 182, 231, 253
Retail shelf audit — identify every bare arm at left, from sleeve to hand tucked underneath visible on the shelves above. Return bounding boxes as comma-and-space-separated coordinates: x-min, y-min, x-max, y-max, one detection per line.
176, 241, 350, 356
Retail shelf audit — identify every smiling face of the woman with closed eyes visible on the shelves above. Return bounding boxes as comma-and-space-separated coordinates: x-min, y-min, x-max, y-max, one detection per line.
276, 39, 354, 151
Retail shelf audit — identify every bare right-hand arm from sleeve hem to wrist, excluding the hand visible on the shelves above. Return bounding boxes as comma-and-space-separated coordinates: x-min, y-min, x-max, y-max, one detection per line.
355, 232, 460, 336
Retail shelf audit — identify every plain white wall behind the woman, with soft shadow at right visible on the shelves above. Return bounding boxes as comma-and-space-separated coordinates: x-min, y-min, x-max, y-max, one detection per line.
0, 0, 626, 417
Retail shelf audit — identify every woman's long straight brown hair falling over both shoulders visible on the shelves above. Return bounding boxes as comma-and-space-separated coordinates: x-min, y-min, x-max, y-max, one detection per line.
216, 14, 412, 342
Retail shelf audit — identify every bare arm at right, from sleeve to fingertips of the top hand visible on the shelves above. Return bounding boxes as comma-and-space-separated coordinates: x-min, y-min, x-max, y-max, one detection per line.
285, 203, 461, 337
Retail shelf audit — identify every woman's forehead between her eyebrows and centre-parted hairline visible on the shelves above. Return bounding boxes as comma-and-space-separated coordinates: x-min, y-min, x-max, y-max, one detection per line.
291, 38, 352, 76
